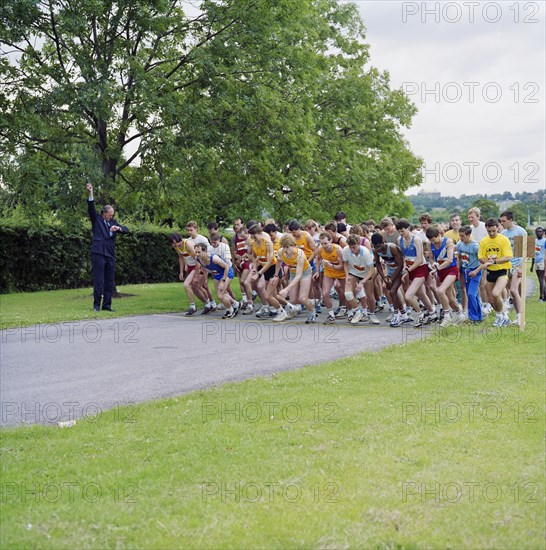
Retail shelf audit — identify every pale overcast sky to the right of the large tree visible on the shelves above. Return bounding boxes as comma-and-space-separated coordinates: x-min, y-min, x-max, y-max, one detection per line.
354, 0, 546, 195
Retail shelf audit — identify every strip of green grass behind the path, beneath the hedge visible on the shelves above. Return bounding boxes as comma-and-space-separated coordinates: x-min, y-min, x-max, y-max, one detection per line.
0, 283, 192, 329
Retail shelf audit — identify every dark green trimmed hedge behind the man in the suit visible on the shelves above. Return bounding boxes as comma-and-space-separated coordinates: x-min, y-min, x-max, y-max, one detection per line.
0, 221, 178, 293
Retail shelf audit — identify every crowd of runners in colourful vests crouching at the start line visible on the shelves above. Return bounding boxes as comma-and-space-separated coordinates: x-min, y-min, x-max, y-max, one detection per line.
169, 208, 546, 327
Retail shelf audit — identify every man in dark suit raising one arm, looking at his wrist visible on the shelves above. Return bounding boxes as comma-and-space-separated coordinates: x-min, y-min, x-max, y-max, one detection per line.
86, 183, 129, 311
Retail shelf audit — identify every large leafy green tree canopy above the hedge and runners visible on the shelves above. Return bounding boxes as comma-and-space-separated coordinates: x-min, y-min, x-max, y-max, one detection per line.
0, 0, 420, 224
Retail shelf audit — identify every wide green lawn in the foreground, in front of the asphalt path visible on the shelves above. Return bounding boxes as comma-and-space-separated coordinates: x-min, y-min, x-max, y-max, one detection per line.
0, 300, 546, 549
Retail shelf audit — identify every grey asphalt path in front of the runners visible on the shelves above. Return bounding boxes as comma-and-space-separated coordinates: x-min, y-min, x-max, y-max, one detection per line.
0, 312, 422, 426
